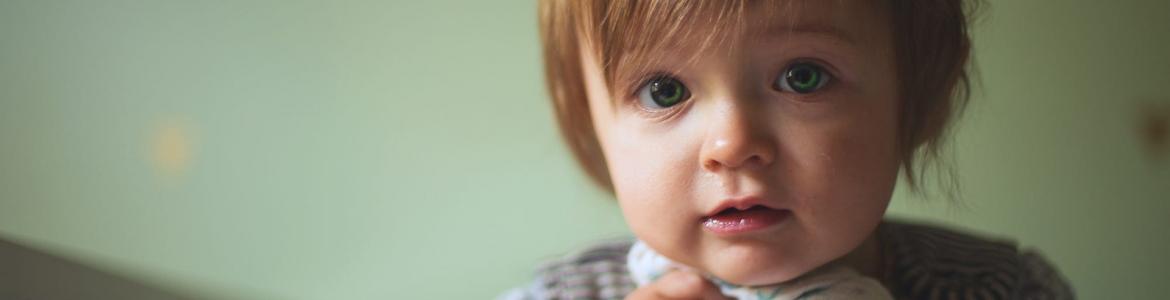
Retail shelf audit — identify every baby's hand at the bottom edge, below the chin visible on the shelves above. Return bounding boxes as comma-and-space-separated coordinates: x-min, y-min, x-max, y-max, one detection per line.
626, 270, 729, 300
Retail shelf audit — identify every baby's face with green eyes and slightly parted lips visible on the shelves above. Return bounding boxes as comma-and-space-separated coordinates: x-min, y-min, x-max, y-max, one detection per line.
583, 1, 899, 285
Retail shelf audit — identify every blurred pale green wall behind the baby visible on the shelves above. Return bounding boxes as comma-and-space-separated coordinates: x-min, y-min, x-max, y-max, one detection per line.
0, 0, 1170, 299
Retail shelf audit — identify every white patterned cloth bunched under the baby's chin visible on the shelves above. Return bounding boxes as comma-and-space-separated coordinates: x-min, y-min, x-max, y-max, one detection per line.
626, 240, 893, 300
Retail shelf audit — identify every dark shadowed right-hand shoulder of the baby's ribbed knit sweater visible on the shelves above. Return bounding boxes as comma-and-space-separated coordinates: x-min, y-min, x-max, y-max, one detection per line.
878, 223, 1073, 299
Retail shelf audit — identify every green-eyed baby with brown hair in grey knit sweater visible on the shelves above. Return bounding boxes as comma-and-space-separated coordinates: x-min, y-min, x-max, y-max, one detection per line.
509, 0, 1071, 299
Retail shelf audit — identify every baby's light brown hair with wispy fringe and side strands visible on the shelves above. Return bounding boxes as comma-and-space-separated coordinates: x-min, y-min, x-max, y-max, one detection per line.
539, 0, 977, 192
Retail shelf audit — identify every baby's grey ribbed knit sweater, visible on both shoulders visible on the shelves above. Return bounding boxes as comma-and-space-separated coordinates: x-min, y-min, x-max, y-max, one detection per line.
502, 221, 1074, 299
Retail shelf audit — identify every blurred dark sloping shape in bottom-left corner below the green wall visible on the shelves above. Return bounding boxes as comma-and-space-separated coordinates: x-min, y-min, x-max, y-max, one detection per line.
0, 238, 194, 300
